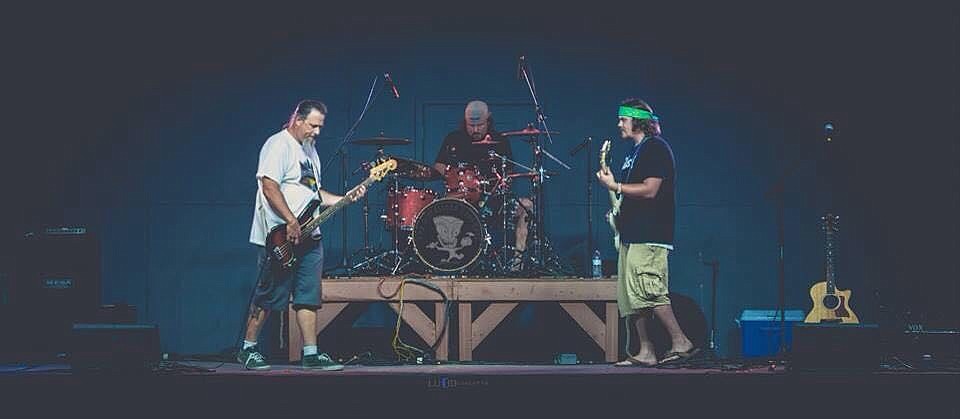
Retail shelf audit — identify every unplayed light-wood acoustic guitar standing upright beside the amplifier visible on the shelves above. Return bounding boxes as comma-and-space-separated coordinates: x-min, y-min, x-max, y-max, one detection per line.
804, 213, 860, 323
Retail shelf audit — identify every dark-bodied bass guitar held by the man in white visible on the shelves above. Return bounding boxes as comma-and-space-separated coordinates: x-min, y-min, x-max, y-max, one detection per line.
266, 159, 397, 269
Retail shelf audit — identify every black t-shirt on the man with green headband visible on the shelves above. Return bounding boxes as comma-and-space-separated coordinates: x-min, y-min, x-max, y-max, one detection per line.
617, 137, 677, 245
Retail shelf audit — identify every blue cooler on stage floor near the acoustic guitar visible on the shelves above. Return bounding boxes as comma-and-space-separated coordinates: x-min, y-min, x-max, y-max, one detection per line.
737, 310, 806, 358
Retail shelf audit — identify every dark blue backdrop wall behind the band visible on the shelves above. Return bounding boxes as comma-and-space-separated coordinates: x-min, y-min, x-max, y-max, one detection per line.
3, 6, 958, 360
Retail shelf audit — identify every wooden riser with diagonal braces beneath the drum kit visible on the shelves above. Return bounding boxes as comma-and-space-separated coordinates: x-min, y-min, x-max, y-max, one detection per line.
288, 277, 619, 362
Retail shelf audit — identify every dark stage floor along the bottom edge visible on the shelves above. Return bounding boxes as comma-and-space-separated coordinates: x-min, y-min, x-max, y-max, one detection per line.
0, 362, 960, 418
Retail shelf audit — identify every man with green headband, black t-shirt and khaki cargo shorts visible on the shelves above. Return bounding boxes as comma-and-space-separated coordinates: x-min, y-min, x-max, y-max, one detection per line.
597, 99, 699, 367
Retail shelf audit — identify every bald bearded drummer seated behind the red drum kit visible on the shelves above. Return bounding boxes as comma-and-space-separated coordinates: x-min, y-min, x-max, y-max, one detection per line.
433, 100, 533, 269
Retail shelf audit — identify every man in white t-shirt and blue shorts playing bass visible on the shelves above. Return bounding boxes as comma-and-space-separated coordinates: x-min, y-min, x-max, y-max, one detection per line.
237, 100, 366, 371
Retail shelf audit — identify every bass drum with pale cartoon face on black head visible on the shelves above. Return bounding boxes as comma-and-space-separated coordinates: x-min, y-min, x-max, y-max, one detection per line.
412, 198, 487, 272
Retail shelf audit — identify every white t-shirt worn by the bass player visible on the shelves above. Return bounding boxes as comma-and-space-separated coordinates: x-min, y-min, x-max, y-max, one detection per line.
250, 129, 320, 246
